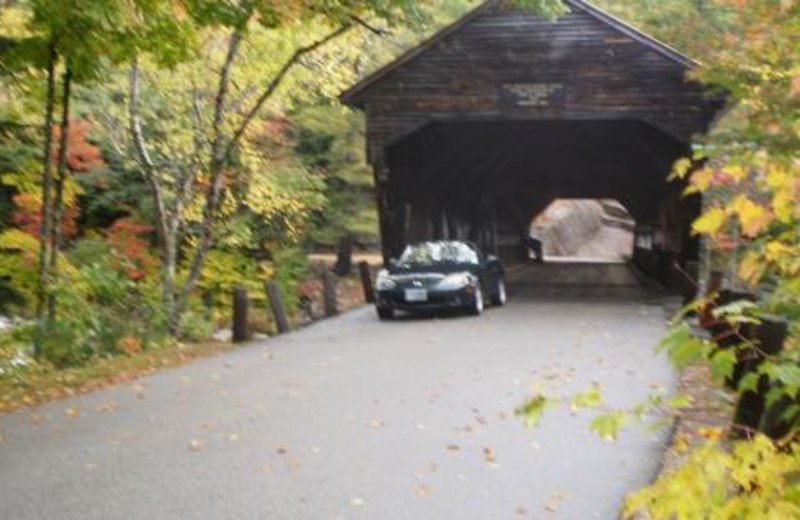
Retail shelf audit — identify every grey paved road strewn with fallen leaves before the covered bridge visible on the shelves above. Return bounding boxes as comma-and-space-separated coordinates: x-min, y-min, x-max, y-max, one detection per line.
0, 274, 674, 520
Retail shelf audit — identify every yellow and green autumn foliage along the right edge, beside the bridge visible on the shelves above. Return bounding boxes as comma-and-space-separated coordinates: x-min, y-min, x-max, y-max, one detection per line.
627, 0, 800, 519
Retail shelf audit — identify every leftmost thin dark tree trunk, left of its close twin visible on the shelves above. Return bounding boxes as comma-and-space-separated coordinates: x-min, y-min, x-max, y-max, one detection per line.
34, 42, 58, 358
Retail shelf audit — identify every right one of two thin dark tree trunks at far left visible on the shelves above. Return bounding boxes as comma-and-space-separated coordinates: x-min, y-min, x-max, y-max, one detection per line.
47, 65, 72, 320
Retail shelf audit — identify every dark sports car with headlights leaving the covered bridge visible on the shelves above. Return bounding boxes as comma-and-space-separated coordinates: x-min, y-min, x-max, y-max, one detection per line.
376, 241, 506, 320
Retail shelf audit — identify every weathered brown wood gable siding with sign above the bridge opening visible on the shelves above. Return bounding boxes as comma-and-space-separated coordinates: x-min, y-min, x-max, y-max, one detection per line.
347, 2, 714, 163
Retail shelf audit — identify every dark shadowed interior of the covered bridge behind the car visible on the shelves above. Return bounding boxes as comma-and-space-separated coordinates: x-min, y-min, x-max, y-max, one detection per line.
382, 120, 700, 284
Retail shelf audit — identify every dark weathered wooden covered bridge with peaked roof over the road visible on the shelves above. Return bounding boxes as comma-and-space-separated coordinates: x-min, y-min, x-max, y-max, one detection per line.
342, 0, 721, 282
